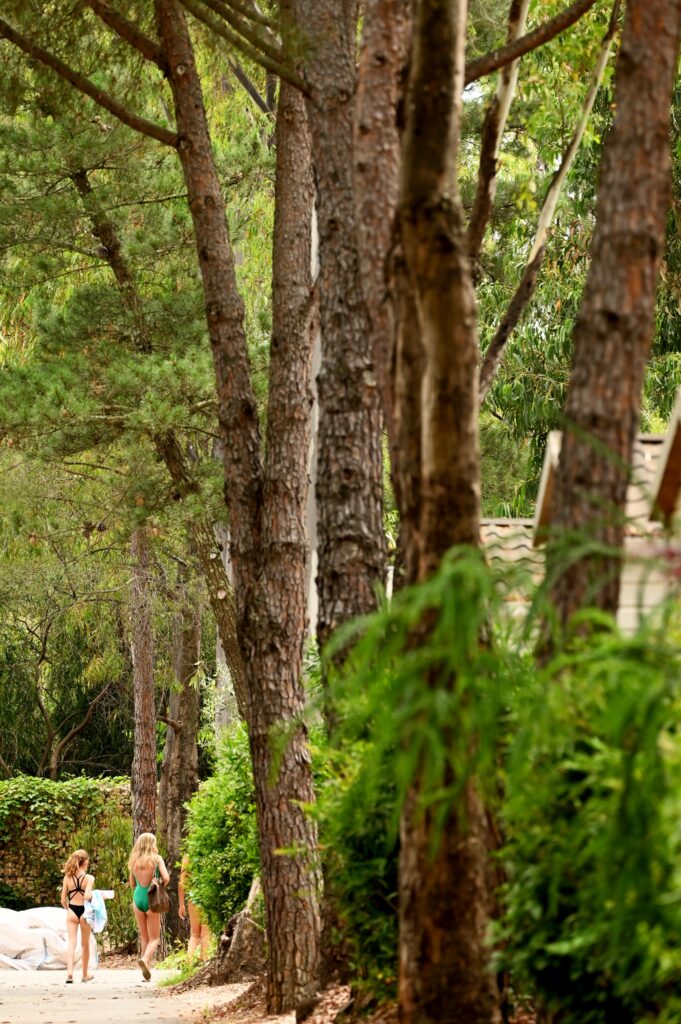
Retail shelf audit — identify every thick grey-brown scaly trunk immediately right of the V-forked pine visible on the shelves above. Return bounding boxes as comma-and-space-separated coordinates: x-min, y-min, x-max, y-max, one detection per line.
294, 0, 386, 659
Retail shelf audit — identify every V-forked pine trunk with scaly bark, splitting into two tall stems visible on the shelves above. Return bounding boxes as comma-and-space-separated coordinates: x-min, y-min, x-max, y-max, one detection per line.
156, 0, 318, 1013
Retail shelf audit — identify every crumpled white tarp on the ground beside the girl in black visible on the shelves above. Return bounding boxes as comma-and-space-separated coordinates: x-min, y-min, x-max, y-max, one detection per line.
0, 906, 97, 971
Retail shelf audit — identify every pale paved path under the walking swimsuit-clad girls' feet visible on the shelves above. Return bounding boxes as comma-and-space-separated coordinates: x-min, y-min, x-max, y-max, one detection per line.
0, 968, 246, 1024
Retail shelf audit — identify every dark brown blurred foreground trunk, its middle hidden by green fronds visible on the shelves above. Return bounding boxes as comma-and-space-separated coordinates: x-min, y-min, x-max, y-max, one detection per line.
394, 0, 500, 1024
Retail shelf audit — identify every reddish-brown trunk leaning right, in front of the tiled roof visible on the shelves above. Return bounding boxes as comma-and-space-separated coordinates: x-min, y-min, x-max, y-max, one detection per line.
548, 0, 681, 624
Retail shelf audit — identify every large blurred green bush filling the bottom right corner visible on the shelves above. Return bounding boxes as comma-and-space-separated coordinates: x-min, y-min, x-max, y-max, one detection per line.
498, 621, 681, 1024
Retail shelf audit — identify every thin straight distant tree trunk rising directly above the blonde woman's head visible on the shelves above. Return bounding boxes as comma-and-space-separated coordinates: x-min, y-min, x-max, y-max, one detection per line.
130, 526, 156, 839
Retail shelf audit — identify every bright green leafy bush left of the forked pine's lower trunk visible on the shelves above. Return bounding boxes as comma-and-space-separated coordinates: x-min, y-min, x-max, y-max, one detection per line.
184, 725, 259, 934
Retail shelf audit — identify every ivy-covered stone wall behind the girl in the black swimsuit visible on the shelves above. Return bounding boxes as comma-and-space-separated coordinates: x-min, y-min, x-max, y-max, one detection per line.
0, 779, 131, 908
